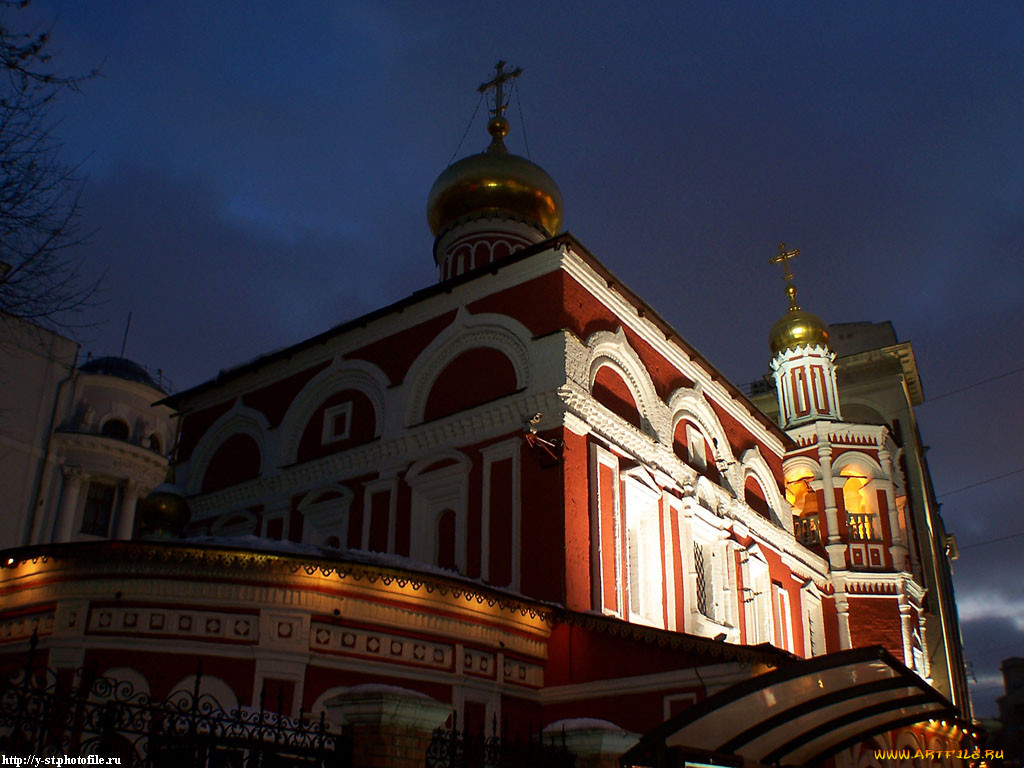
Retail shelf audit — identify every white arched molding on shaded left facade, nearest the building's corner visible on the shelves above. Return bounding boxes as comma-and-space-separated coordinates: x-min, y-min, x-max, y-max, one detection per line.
402, 307, 532, 426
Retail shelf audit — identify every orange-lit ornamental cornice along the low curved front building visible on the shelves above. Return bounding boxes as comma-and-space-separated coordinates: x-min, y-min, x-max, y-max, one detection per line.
3, 544, 557, 658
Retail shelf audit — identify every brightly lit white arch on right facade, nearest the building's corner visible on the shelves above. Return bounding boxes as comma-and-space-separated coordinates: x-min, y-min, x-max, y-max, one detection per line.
587, 327, 672, 447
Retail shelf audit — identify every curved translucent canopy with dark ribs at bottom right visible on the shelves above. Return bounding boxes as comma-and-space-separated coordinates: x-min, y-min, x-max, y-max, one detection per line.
620, 646, 956, 768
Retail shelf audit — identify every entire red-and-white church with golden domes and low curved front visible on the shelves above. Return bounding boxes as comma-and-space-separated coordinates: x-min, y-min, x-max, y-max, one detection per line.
0, 70, 970, 765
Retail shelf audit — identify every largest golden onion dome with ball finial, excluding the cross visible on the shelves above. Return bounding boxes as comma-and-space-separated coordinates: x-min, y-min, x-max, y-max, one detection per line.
427, 116, 562, 237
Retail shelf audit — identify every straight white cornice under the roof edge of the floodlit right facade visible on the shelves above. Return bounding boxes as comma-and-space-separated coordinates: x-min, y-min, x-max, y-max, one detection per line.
561, 247, 783, 456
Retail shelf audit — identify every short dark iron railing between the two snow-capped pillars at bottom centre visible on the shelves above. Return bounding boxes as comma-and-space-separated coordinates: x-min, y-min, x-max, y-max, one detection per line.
426, 716, 575, 768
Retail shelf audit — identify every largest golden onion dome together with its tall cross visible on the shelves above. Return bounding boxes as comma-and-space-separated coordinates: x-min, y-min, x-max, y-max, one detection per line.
427, 61, 562, 279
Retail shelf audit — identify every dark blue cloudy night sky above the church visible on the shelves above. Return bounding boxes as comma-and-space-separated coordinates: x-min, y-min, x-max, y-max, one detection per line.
25, 0, 1024, 716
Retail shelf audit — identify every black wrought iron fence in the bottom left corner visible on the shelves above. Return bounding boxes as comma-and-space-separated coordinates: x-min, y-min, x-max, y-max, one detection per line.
0, 635, 351, 768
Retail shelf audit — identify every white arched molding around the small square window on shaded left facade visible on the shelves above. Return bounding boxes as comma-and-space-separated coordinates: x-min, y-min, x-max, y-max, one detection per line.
278, 357, 387, 467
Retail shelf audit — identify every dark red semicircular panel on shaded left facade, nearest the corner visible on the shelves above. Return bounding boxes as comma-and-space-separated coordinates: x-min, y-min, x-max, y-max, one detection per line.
423, 347, 516, 421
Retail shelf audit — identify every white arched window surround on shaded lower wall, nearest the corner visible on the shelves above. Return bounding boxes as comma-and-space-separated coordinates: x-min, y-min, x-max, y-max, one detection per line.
406, 451, 472, 573
